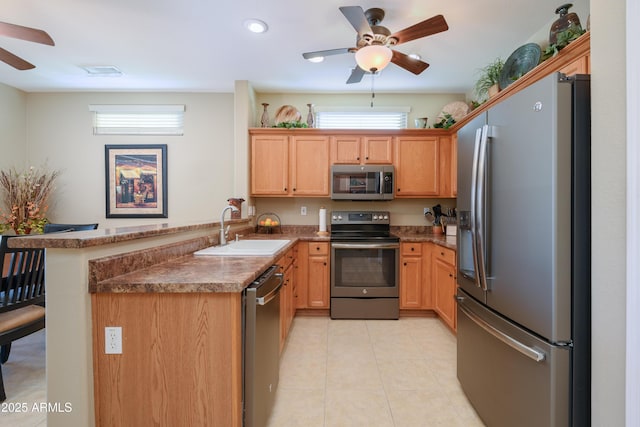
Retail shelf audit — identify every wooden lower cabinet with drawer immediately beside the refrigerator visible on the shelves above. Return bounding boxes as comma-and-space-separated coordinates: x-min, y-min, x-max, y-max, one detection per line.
433, 247, 457, 331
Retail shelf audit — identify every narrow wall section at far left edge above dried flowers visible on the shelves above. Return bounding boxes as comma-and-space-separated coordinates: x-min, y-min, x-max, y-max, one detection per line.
0, 83, 27, 170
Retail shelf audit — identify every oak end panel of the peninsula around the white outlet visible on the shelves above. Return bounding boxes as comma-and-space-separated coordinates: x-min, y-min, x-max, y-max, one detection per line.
91, 292, 242, 427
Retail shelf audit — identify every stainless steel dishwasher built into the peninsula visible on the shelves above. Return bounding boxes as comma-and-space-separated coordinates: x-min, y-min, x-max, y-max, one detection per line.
243, 265, 282, 427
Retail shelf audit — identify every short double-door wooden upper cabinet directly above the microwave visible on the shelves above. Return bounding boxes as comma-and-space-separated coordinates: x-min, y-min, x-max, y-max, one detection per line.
331, 135, 393, 165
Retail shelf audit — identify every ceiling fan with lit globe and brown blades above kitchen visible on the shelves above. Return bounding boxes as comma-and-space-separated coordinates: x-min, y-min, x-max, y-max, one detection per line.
302, 6, 449, 83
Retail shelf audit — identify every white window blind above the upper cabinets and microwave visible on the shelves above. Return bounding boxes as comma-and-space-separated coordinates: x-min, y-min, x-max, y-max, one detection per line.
315, 107, 410, 129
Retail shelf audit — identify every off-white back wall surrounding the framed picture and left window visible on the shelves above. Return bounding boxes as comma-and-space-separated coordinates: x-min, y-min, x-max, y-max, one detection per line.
24, 93, 238, 228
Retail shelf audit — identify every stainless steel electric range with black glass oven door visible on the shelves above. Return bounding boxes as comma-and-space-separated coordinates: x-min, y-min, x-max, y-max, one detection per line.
331, 211, 400, 319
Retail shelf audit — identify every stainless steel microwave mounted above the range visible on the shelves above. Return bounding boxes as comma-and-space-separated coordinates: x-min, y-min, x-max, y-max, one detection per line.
331, 165, 393, 200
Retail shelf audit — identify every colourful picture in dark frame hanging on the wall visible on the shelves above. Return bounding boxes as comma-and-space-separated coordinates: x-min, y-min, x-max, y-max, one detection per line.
104, 144, 167, 218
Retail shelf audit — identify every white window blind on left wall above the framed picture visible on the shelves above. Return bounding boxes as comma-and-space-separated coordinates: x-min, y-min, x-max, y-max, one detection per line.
89, 105, 185, 135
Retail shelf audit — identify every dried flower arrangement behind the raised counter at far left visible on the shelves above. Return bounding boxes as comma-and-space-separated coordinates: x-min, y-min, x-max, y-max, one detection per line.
0, 166, 60, 234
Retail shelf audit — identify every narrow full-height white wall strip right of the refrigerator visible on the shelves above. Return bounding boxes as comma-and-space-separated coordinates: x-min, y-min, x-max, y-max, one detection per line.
591, 0, 638, 427
